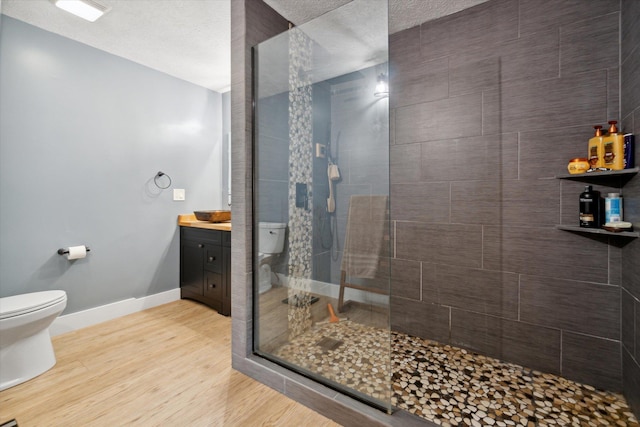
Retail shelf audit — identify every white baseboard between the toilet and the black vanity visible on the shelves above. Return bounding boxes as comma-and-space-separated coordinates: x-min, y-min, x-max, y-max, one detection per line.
49, 288, 180, 337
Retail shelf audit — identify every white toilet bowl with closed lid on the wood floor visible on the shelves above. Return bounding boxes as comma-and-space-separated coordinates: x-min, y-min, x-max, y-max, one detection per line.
0, 291, 67, 391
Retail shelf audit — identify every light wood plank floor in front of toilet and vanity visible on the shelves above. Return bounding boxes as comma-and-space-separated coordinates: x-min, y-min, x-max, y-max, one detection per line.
0, 300, 338, 427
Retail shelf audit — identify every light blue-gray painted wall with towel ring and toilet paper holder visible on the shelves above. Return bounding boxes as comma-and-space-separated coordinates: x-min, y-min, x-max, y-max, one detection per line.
0, 15, 229, 313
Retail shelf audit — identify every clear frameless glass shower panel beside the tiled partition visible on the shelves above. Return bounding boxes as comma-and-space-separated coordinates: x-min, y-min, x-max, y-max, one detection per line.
253, 0, 391, 411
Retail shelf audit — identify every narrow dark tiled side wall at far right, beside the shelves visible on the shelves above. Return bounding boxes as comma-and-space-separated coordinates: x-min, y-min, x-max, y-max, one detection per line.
620, 0, 640, 416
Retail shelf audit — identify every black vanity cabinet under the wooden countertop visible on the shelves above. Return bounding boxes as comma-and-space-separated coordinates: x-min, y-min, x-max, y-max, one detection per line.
180, 227, 231, 316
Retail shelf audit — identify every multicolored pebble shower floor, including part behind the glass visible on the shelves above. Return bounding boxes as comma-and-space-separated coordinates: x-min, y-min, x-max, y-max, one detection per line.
276, 321, 640, 427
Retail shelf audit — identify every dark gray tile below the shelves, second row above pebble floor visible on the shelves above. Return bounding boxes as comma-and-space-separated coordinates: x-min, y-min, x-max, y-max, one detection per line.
520, 275, 620, 340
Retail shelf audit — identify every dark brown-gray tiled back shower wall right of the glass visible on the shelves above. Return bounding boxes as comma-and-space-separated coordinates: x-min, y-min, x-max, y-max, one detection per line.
390, 0, 638, 390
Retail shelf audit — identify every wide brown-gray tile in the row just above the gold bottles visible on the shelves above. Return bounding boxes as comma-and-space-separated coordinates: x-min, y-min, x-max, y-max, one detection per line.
482, 70, 608, 135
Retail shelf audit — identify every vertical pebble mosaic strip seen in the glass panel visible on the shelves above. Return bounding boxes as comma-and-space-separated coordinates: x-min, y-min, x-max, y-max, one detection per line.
288, 28, 313, 338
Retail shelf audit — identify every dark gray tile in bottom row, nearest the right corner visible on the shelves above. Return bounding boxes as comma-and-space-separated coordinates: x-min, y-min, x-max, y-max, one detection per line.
562, 331, 622, 392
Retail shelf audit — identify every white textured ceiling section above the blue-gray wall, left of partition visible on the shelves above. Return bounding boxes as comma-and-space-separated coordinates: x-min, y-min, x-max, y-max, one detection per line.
2, 0, 231, 92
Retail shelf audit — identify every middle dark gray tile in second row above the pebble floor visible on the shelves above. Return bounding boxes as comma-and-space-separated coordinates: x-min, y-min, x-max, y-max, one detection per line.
436, 265, 519, 319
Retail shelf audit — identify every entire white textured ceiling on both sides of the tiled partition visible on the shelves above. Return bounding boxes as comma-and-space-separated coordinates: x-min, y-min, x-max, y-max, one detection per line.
0, 0, 487, 92
